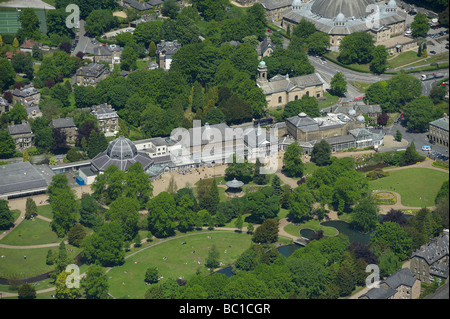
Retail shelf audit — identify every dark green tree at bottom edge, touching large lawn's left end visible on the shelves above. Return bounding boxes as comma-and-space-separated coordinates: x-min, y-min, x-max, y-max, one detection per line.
81, 265, 109, 299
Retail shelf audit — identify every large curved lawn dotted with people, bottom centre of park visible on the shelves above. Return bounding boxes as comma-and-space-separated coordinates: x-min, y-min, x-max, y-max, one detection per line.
107, 230, 251, 299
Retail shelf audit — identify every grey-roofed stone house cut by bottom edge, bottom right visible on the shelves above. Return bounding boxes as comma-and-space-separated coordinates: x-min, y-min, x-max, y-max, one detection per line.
359, 268, 420, 299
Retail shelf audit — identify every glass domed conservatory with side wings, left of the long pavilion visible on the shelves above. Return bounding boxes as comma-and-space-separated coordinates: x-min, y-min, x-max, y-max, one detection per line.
91, 136, 153, 173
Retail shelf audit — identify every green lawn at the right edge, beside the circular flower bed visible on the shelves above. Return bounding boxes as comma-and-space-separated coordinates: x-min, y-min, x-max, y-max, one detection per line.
369, 167, 448, 207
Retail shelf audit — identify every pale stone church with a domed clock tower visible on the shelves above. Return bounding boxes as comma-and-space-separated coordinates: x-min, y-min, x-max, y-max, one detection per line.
256, 61, 324, 109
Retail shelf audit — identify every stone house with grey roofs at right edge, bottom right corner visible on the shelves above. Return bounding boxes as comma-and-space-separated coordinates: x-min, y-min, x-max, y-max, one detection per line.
409, 229, 449, 284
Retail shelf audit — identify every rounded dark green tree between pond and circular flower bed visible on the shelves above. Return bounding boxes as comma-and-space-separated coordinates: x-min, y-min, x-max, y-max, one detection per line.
352, 196, 378, 233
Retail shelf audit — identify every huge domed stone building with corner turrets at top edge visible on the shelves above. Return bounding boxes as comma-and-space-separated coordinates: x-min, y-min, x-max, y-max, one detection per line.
282, 0, 407, 48
